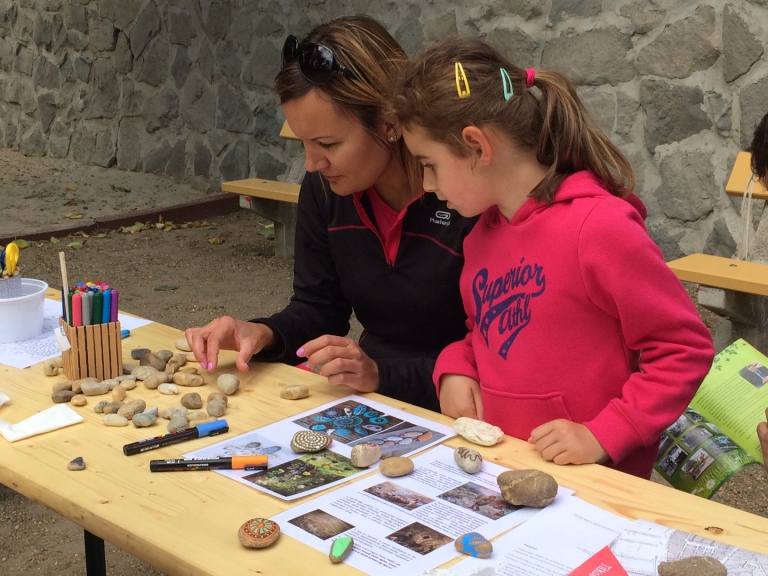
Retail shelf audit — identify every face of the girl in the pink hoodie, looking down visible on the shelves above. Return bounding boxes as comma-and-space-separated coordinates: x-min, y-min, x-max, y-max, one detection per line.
403, 126, 495, 218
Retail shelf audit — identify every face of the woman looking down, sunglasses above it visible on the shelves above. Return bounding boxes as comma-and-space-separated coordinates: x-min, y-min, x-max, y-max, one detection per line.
283, 89, 398, 196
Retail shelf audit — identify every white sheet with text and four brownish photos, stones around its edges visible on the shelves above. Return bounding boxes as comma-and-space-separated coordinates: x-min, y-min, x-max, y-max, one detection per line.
273, 446, 572, 576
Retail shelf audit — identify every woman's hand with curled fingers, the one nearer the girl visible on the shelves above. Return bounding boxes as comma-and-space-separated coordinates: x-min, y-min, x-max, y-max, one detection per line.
296, 334, 379, 392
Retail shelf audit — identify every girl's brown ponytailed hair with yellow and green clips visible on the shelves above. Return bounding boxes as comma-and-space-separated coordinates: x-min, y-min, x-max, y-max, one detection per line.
391, 36, 635, 202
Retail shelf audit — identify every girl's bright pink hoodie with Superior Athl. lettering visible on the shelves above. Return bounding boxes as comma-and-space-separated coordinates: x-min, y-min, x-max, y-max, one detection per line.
434, 171, 714, 478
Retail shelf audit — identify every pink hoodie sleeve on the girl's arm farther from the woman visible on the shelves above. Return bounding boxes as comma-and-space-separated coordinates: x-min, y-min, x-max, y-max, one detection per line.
578, 201, 714, 462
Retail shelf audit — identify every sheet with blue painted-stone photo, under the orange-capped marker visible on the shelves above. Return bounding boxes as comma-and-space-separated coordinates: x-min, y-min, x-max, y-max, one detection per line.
184, 395, 456, 500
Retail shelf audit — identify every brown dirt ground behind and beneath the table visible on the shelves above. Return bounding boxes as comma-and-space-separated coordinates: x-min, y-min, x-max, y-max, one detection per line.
0, 148, 768, 576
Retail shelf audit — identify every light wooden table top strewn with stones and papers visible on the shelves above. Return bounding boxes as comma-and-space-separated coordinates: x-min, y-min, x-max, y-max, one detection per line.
0, 304, 768, 576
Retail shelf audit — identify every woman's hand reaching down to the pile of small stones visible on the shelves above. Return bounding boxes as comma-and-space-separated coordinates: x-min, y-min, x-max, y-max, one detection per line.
184, 316, 275, 372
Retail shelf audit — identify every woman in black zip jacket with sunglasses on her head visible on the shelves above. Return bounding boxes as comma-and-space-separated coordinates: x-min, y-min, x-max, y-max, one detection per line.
186, 16, 475, 410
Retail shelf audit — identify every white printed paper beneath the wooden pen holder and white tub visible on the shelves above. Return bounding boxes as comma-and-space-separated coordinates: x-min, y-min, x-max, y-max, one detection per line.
0, 298, 152, 369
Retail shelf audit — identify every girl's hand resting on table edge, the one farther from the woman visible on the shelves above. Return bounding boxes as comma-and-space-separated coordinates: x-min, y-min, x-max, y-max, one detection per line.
528, 419, 608, 464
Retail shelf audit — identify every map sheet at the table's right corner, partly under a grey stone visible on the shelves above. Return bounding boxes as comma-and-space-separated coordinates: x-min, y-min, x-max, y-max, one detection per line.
611, 520, 768, 576
